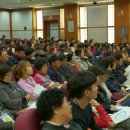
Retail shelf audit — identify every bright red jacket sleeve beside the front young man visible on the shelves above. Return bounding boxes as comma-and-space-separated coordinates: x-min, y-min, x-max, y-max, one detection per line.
94, 105, 112, 128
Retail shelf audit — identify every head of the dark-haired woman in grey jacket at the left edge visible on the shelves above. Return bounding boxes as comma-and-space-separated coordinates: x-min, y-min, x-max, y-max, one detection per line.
0, 64, 12, 84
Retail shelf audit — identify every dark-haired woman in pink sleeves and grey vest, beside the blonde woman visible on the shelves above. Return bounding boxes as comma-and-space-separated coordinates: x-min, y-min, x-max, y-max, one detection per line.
34, 57, 60, 88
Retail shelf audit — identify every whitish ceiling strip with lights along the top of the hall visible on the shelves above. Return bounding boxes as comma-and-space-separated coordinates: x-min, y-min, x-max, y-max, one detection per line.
0, 0, 114, 9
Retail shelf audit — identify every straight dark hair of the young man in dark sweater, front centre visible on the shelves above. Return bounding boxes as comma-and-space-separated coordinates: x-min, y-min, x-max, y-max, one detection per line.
67, 71, 96, 98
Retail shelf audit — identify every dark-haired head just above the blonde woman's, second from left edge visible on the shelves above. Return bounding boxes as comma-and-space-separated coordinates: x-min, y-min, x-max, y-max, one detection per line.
15, 45, 25, 59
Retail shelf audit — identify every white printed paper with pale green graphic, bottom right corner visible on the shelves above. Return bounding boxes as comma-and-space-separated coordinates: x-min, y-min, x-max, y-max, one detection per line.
111, 107, 130, 124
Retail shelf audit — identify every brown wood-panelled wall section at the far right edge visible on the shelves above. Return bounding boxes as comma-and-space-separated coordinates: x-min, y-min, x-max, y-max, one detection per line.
114, 0, 130, 43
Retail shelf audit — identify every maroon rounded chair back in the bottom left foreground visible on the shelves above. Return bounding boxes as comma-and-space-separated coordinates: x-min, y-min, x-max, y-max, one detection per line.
14, 108, 42, 130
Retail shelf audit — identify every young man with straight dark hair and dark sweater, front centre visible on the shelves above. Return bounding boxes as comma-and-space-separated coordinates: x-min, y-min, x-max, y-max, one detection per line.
67, 71, 102, 130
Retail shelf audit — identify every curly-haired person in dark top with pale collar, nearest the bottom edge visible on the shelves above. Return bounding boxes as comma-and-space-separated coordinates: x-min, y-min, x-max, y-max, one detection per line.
37, 88, 82, 130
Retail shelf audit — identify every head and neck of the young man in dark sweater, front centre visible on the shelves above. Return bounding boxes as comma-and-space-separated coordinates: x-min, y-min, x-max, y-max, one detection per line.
67, 71, 98, 103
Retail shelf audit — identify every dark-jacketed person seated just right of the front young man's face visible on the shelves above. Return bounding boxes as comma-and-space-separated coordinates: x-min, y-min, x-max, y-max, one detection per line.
89, 66, 130, 113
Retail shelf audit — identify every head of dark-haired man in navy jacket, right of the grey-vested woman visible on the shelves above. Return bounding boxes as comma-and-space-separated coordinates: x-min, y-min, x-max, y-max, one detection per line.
48, 54, 60, 69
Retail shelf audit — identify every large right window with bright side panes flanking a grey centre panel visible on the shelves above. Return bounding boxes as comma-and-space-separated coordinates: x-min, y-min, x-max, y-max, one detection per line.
79, 4, 115, 43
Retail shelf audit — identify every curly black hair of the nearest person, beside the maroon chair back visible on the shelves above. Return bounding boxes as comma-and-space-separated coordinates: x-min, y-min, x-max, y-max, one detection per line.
36, 88, 64, 121
